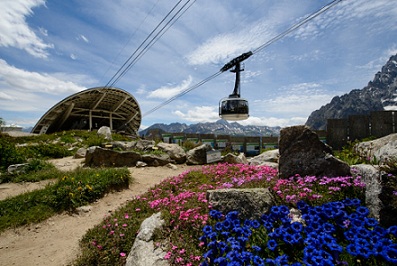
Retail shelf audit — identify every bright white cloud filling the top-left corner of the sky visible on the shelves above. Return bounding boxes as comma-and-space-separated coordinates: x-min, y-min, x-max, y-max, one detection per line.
0, 0, 53, 58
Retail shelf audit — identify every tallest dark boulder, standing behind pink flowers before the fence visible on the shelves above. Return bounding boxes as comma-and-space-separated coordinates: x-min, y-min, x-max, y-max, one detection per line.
279, 126, 350, 178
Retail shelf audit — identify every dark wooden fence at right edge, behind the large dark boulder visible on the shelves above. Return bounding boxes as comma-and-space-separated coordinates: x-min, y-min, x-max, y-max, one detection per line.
326, 111, 397, 150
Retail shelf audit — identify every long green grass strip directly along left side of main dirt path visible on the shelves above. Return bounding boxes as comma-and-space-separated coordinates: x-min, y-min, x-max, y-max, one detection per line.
0, 168, 131, 232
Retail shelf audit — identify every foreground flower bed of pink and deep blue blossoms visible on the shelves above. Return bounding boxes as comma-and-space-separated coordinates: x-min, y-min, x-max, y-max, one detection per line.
75, 163, 396, 265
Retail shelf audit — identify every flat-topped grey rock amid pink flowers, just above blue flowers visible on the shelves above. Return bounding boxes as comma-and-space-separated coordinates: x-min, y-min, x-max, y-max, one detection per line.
207, 188, 275, 219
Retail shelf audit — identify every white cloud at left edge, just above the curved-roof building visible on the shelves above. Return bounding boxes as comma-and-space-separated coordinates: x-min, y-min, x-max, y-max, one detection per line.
0, 59, 86, 94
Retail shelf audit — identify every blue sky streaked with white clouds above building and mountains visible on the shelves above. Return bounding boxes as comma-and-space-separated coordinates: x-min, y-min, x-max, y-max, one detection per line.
0, 0, 397, 128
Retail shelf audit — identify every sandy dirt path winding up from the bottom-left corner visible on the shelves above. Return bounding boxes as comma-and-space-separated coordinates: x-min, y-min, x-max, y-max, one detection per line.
0, 158, 198, 266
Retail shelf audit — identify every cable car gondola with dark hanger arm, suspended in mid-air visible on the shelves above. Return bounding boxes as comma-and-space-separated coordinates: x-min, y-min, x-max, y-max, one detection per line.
219, 52, 252, 121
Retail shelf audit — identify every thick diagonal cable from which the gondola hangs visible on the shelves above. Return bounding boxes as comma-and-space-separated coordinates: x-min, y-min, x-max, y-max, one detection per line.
142, 0, 343, 117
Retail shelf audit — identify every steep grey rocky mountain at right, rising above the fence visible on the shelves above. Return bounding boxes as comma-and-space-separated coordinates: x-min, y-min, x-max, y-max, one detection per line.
306, 55, 397, 130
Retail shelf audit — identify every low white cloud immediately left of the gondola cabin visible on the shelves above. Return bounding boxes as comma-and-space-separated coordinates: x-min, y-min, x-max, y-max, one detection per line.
174, 106, 219, 123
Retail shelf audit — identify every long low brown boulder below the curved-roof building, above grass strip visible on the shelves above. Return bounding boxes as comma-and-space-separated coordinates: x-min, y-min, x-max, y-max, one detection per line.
85, 146, 142, 167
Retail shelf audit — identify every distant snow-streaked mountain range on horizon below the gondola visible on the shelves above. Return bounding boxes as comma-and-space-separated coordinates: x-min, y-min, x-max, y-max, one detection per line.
139, 120, 281, 137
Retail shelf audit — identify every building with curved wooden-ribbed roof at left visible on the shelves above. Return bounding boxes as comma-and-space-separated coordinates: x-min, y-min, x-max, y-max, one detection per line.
31, 87, 142, 135
